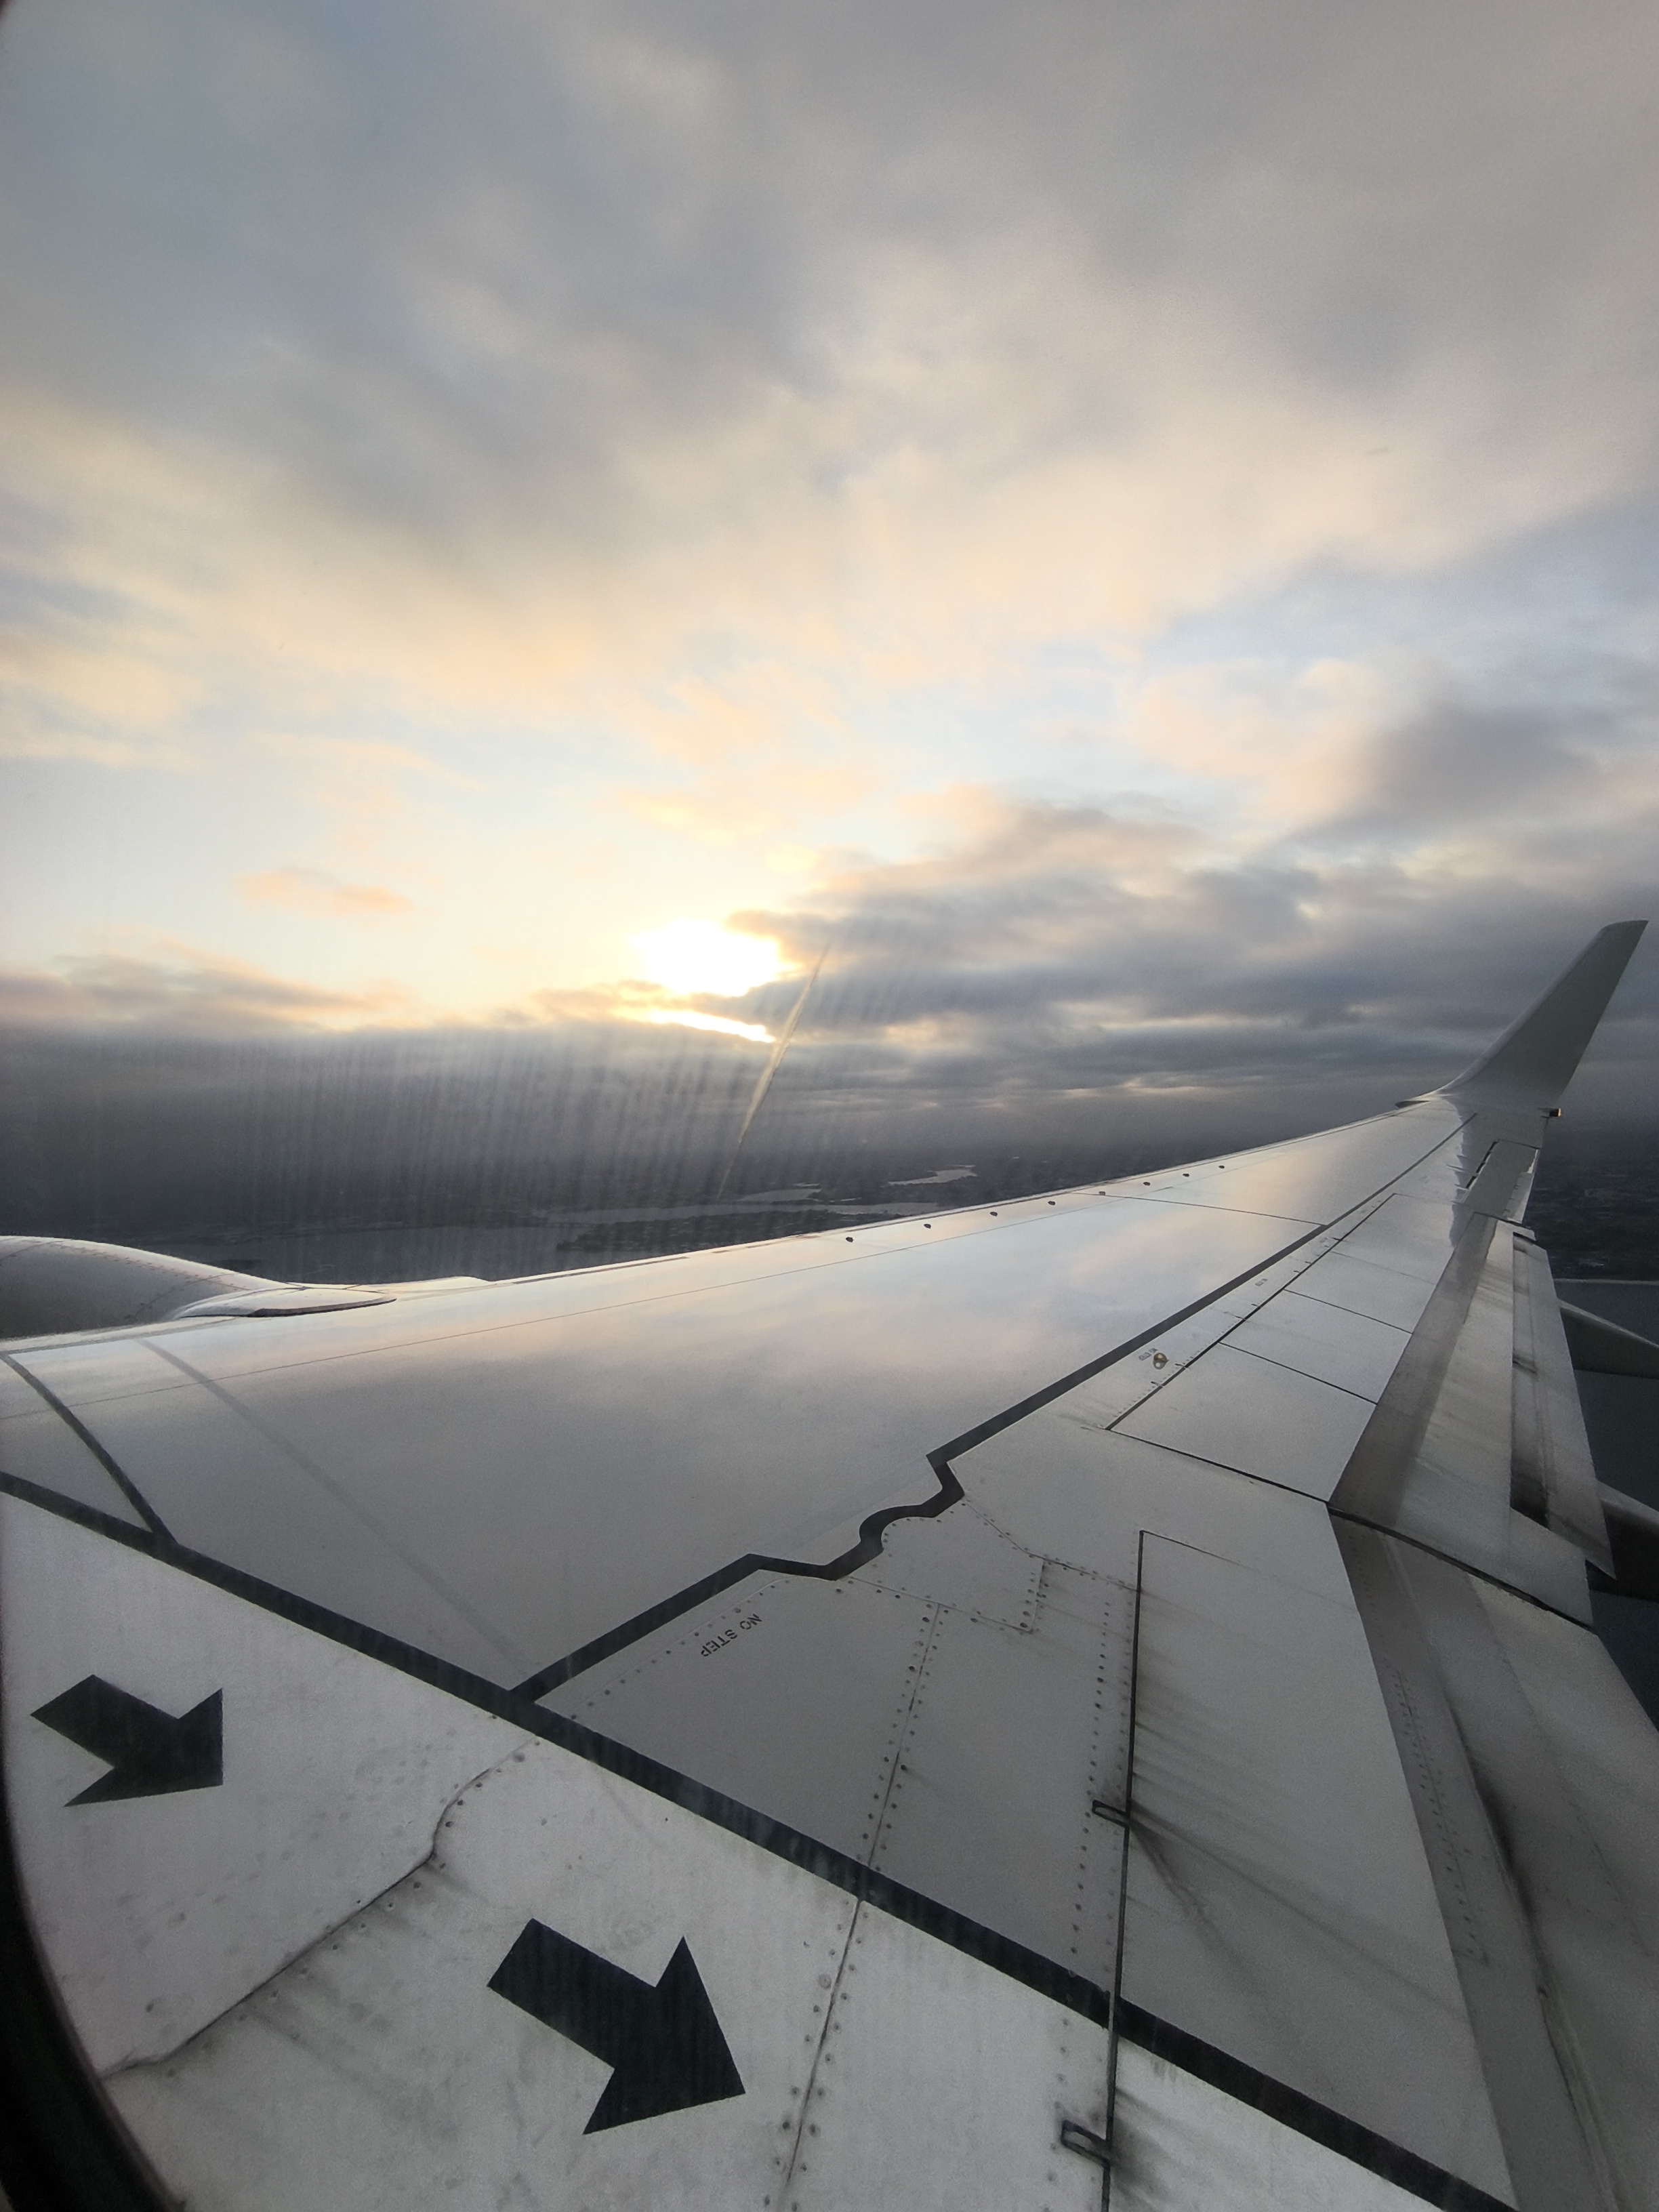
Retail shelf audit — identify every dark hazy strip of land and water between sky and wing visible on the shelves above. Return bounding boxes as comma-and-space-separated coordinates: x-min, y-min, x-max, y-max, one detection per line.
0, 1008, 1659, 1281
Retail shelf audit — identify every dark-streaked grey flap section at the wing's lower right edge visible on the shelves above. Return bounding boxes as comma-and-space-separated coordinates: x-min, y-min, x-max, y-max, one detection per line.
1338, 1524, 1659, 2212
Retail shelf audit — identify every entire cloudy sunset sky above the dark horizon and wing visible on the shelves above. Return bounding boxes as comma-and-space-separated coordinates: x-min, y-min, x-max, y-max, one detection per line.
0, 0, 1659, 1124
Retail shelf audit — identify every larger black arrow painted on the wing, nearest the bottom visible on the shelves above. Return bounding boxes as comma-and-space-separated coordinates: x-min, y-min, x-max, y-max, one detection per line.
489, 1920, 743, 2135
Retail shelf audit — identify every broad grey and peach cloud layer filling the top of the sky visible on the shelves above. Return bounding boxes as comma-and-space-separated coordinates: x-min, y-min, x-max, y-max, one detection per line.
0, 0, 1659, 787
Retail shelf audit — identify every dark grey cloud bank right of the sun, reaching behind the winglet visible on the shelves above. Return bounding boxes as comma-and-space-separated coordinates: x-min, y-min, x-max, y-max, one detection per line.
728, 787, 1659, 1113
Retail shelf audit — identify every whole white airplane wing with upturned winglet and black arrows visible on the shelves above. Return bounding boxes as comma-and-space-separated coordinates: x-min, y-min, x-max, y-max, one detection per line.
0, 922, 1659, 2212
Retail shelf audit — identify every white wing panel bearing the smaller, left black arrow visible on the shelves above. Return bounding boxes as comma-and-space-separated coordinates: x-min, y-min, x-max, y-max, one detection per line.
0, 1498, 527, 2072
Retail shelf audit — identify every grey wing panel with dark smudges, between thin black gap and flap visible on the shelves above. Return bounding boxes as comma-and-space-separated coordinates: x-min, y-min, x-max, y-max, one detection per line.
1124, 1535, 1511, 2196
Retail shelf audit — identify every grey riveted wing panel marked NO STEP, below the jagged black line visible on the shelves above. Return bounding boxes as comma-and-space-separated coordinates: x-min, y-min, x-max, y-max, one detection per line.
544, 1530, 1132, 1991
